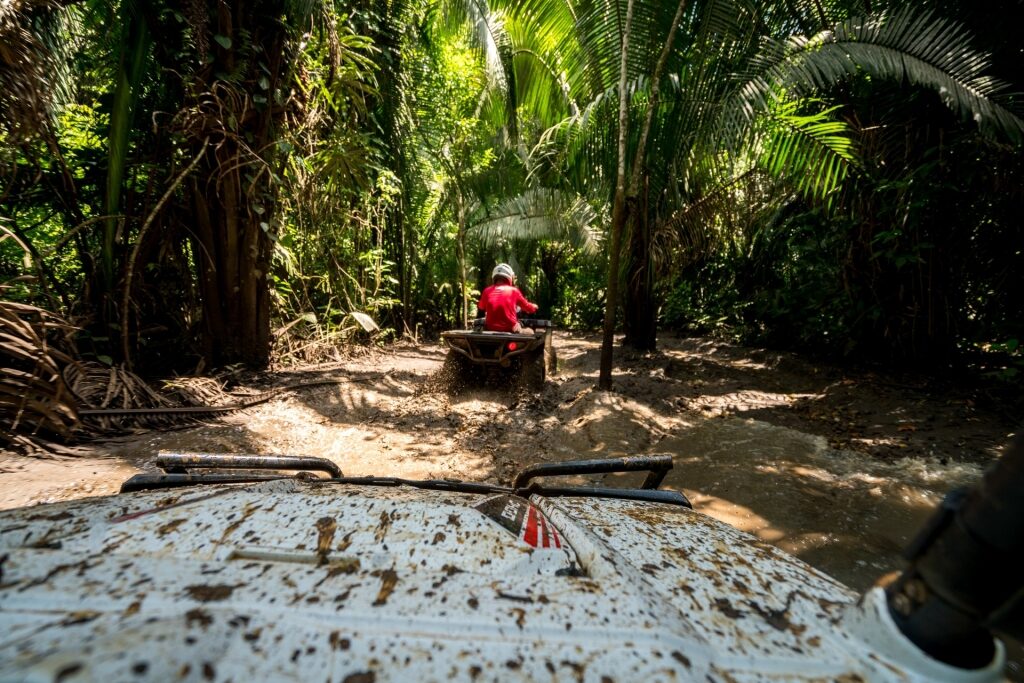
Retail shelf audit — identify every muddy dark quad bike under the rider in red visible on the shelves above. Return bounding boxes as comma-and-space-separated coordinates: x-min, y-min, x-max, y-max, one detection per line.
441, 317, 557, 391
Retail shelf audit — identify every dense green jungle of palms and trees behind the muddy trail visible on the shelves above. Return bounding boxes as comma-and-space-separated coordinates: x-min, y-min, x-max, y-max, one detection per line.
0, 0, 1024, 444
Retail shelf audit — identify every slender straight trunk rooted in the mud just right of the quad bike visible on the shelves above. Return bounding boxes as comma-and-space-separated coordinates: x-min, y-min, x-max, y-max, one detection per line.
597, 0, 633, 391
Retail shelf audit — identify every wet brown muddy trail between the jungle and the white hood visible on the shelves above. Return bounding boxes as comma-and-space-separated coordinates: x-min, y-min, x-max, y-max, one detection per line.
0, 334, 1013, 589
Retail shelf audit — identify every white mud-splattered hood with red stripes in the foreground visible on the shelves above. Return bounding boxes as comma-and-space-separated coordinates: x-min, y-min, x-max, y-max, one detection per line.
0, 480, 995, 683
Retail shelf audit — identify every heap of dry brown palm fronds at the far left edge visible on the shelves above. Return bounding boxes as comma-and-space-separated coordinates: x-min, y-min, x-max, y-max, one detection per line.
0, 288, 79, 453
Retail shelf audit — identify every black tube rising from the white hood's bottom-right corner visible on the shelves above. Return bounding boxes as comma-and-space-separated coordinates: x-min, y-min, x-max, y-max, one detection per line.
886, 433, 1024, 669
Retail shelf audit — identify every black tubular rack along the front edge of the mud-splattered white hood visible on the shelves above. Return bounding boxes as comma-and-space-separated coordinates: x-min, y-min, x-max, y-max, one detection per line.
121, 453, 693, 508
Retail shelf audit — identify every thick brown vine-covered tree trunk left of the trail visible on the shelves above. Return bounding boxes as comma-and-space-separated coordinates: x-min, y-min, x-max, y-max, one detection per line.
180, 0, 290, 368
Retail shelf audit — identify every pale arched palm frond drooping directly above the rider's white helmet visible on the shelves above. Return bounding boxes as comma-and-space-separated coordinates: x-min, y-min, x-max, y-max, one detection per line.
471, 187, 598, 255
